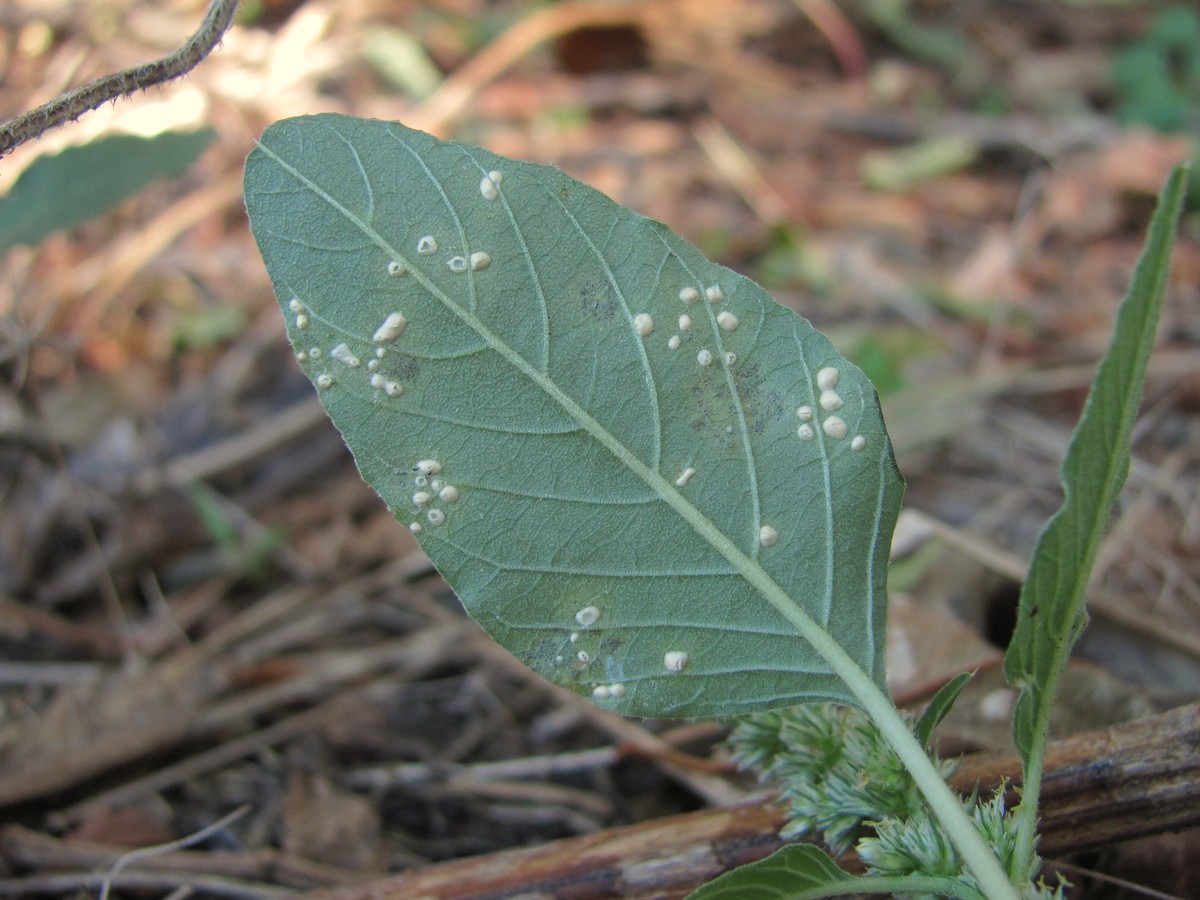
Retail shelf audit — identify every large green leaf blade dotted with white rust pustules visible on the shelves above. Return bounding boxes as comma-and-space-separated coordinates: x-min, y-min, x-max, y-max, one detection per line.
246, 115, 902, 716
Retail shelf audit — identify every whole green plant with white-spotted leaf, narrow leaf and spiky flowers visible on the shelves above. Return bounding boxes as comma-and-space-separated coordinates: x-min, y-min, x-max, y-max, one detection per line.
245, 115, 1186, 898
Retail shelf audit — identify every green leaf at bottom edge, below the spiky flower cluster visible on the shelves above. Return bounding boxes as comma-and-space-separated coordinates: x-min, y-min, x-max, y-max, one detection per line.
688, 844, 982, 900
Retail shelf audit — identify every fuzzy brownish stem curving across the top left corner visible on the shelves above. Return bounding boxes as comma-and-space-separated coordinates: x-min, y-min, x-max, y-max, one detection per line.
0, 0, 238, 157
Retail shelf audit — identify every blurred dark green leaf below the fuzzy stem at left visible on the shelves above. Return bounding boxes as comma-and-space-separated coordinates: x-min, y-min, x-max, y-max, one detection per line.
0, 128, 216, 253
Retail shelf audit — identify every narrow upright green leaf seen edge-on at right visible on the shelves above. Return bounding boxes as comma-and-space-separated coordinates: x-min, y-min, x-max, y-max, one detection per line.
1004, 166, 1188, 763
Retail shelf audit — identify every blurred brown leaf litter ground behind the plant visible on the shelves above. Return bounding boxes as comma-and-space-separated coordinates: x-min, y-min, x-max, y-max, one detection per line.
0, 0, 1200, 896
